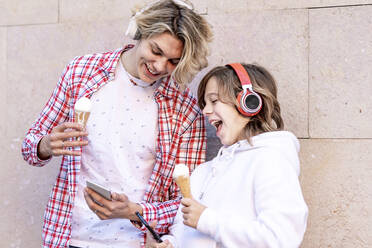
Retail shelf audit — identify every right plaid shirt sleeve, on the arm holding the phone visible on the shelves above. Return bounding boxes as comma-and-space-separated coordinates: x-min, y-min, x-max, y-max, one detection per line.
140, 98, 206, 234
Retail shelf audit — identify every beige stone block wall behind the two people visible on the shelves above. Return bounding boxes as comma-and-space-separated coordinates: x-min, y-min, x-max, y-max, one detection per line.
0, 0, 372, 248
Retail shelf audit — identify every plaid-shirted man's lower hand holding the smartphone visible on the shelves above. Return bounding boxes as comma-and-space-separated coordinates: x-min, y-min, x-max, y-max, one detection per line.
84, 188, 143, 221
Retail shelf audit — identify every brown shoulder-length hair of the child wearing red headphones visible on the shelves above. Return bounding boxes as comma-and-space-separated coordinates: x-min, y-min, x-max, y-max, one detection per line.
198, 64, 284, 140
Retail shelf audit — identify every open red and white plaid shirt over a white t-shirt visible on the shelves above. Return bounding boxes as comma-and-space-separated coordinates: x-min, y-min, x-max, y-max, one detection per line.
22, 45, 206, 248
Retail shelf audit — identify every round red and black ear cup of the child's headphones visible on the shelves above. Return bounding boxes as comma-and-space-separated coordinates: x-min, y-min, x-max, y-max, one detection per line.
237, 90, 262, 117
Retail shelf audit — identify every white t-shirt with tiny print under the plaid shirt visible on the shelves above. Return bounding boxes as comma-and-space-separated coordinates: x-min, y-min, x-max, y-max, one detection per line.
70, 58, 160, 248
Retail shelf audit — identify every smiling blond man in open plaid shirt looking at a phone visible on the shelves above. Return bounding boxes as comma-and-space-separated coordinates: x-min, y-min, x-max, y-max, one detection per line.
22, 0, 212, 248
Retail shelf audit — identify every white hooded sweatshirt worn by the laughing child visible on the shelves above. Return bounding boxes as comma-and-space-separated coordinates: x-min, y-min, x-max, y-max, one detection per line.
163, 131, 308, 248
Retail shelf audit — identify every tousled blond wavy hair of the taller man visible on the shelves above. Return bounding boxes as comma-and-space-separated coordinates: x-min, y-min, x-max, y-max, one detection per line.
134, 0, 212, 86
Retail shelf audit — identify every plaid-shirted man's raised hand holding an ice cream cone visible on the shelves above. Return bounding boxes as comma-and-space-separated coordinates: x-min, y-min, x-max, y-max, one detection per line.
37, 122, 88, 160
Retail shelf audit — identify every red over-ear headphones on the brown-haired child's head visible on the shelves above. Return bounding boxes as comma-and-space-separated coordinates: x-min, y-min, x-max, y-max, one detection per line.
226, 63, 262, 116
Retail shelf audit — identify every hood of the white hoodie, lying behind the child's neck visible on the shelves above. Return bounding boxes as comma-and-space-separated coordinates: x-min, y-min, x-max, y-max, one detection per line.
216, 131, 300, 175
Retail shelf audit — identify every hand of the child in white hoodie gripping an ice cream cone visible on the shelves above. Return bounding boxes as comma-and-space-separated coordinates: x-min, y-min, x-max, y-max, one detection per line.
181, 198, 207, 229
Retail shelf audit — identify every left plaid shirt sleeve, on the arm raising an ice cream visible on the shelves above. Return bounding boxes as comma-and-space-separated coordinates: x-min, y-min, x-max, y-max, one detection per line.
22, 61, 71, 167
